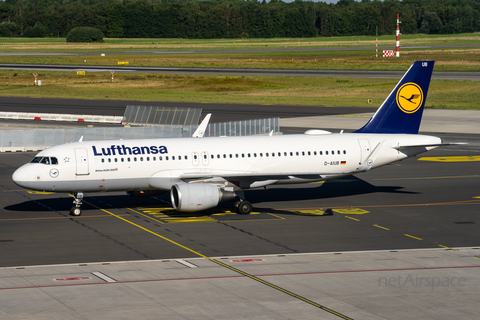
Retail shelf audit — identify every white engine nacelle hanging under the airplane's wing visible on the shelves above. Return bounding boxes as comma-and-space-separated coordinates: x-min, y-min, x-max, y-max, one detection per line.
170, 183, 235, 212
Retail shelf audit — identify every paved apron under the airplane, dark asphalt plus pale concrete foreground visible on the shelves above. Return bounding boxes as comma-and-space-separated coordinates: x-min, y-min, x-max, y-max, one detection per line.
0, 102, 480, 319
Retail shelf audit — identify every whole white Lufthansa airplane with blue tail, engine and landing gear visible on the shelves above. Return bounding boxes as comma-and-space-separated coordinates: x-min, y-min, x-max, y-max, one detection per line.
12, 61, 451, 216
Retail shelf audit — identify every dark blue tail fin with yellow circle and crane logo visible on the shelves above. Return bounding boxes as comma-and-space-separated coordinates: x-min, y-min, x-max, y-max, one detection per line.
355, 61, 435, 134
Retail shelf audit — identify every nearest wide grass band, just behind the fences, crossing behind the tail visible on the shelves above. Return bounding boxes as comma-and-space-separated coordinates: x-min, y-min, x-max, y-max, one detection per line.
0, 71, 480, 109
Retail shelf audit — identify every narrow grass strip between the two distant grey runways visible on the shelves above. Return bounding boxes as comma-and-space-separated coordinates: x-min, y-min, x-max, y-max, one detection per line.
0, 48, 480, 71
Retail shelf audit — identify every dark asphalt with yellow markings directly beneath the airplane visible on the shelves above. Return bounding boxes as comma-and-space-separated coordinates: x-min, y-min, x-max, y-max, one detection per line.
0, 125, 480, 267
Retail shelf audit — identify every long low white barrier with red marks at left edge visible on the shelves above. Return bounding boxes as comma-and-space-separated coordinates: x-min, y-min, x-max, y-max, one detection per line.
0, 111, 123, 123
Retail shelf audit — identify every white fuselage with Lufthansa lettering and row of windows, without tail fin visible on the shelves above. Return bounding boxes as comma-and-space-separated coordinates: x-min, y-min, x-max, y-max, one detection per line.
13, 133, 441, 192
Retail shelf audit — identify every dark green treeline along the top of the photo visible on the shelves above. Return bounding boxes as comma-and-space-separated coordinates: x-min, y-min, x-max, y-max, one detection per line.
0, 0, 480, 39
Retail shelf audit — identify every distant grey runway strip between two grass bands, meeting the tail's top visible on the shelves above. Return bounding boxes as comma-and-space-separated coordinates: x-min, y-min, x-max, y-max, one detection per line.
0, 63, 480, 80
